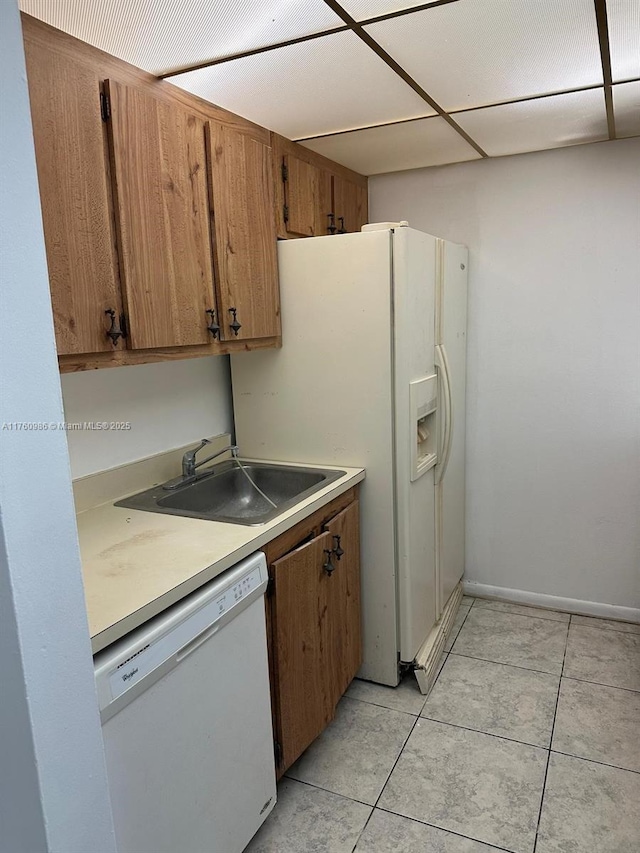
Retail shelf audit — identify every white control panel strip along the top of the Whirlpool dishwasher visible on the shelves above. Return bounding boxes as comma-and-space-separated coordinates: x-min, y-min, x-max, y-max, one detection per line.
94, 552, 268, 713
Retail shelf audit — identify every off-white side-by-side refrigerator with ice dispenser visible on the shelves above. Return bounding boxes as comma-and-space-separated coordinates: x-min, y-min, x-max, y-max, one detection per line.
231, 223, 468, 692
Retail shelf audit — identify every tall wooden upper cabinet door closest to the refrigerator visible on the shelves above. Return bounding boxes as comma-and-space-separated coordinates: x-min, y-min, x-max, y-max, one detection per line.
207, 121, 280, 341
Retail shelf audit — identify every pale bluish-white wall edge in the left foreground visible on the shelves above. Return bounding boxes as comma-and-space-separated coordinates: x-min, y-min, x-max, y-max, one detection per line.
0, 0, 115, 853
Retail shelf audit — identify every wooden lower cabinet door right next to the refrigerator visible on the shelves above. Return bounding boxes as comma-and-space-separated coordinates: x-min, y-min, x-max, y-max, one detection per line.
324, 501, 362, 704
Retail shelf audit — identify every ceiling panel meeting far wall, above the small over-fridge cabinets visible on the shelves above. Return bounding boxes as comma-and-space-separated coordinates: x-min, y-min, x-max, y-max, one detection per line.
302, 117, 480, 175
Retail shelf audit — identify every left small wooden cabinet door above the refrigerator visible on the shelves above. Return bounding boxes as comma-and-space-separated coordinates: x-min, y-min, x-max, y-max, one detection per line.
283, 154, 333, 237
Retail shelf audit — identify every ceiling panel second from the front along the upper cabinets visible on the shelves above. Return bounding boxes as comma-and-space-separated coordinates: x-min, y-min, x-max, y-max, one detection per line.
171, 32, 433, 138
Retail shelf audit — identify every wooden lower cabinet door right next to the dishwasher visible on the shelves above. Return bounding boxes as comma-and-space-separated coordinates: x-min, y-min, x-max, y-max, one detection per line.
272, 533, 336, 770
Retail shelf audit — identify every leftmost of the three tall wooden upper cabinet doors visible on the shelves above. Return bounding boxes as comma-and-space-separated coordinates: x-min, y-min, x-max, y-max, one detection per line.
25, 38, 123, 355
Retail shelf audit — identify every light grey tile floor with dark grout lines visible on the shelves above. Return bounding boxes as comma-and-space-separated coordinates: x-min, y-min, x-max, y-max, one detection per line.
246, 597, 640, 853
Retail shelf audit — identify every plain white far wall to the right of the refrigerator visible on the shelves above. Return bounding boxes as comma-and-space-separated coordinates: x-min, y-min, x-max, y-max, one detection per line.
370, 139, 640, 608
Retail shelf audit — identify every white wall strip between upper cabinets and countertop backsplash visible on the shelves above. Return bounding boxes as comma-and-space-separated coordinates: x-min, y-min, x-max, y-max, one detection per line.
62, 356, 233, 479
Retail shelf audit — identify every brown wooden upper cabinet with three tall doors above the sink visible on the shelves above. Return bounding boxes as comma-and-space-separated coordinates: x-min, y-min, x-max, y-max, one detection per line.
23, 18, 280, 370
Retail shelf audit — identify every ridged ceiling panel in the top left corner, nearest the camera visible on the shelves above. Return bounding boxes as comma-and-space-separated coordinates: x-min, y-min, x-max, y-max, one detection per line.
20, 0, 343, 74
